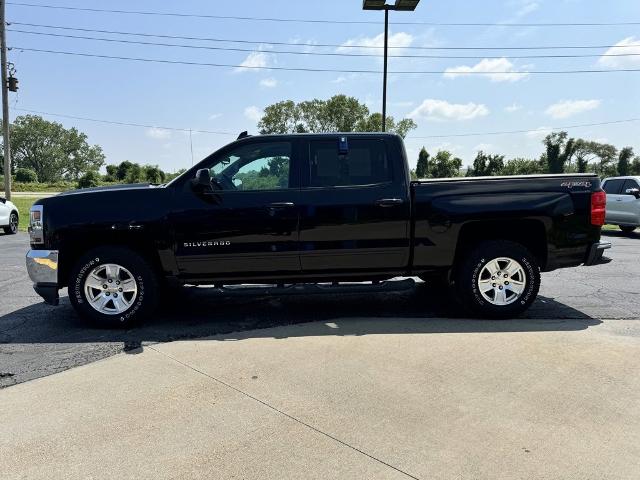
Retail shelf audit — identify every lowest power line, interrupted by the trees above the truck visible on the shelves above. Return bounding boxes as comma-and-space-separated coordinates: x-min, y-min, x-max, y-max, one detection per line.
15, 108, 640, 139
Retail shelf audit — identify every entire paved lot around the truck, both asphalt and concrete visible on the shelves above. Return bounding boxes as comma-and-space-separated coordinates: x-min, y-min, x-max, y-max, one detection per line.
0, 232, 640, 479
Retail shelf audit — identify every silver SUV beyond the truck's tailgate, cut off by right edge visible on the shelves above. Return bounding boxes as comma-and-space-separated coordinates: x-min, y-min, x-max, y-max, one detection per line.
602, 177, 640, 234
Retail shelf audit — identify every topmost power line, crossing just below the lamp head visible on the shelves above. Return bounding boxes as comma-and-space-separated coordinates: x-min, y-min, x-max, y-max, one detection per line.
6, 2, 640, 27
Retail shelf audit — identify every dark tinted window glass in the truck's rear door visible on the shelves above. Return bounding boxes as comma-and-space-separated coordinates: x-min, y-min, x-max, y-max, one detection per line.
309, 138, 392, 187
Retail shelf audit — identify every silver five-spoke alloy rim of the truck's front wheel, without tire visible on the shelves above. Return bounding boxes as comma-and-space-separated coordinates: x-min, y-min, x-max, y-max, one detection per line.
84, 263, 138, 315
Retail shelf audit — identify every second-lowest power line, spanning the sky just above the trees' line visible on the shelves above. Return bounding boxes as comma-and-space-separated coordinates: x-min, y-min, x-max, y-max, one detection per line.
11, 46, 640, 76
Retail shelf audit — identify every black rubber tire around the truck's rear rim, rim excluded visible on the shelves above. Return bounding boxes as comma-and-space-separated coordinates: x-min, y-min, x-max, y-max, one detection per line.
455, 240, 540, 319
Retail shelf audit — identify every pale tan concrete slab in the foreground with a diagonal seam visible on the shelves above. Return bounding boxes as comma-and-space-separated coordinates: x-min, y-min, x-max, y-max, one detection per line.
0, 318, 640, 480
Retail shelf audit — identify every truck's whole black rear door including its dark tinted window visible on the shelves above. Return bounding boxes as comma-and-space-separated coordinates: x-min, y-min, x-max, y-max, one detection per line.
300, 135, 411, 274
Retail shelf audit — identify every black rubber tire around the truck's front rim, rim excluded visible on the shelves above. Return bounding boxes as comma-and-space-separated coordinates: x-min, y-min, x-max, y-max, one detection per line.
69, 247, 158, 328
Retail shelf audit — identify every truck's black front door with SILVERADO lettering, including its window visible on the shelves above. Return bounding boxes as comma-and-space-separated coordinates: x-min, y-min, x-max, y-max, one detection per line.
170, 140, 300, 280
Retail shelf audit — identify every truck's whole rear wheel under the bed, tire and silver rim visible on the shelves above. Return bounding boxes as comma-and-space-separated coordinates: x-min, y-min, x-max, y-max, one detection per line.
455, 240, 540, 319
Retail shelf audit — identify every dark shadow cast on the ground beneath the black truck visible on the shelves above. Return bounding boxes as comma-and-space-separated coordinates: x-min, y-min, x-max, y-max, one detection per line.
0, 284, 601, 351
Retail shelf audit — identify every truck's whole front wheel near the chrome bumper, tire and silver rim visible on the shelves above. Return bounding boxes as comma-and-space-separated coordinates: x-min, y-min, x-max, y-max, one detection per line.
69, 247, 158, 328
